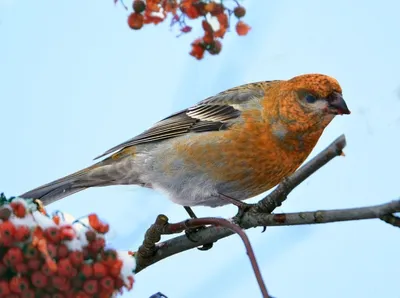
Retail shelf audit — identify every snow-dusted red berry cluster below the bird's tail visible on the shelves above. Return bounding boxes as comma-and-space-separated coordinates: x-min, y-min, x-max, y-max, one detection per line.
0, 196, 135, 298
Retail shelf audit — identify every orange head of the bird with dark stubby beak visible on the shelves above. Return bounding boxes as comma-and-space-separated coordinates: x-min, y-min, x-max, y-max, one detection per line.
279, 74, 350, 130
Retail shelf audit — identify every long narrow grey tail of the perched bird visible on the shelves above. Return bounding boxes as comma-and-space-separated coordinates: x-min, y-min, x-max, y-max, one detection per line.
19, 160, 134, 205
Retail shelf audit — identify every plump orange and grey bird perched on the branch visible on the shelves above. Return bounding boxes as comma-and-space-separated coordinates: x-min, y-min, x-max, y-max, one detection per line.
20, 74, 350, 207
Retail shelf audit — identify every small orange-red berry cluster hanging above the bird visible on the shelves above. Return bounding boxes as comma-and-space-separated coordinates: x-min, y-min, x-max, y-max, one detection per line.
128, 0, 250, 60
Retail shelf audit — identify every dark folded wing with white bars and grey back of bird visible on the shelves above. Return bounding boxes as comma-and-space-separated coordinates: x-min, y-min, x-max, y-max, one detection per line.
95, 81, 271, 159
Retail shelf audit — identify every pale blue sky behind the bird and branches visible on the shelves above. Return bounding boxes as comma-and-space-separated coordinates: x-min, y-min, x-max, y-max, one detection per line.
0, 0, 400, 298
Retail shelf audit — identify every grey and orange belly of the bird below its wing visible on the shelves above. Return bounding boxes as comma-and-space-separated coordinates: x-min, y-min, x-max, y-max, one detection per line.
136, 133, 304, 206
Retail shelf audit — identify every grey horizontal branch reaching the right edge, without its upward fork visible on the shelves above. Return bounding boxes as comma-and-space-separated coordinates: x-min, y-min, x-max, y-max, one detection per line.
136, 199, 400, 272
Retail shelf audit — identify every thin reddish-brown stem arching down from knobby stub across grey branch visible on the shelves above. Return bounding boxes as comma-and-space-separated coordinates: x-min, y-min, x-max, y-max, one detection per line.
136, 214, 270, 298
